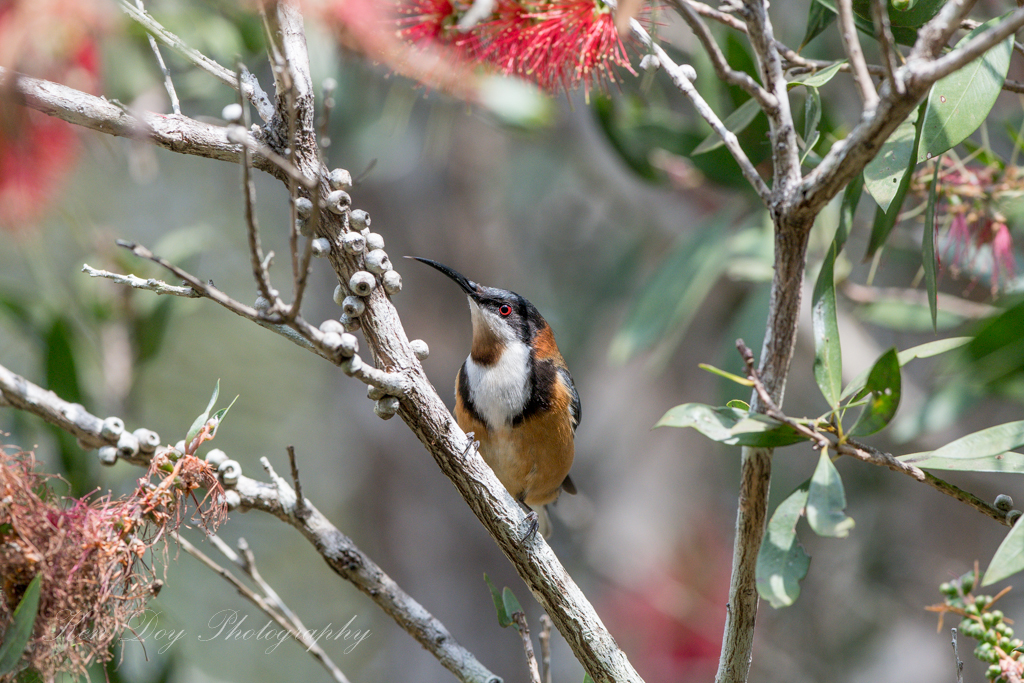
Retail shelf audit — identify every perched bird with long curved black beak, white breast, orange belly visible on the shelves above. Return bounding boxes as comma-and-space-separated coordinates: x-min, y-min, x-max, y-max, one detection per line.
410, 256, 580, 538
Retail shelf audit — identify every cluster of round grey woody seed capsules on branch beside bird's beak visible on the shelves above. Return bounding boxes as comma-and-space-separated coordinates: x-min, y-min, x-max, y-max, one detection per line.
296, 168, 430, 420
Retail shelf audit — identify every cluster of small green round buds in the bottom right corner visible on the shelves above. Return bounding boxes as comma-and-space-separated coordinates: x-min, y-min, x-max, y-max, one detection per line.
939, 571, 1024, 683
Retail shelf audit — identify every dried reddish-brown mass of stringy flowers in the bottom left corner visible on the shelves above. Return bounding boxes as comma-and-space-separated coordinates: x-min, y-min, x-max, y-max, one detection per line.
0, 447, 226, 680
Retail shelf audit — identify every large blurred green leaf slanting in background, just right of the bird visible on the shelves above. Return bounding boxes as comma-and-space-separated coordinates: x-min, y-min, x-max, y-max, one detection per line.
608, 212, 733, 362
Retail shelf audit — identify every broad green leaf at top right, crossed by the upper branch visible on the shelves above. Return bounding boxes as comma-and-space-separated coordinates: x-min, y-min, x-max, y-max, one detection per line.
918, 12, 1014, 161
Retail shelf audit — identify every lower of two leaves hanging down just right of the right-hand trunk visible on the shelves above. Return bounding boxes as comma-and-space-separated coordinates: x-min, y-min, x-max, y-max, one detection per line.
755, 480, 811, 609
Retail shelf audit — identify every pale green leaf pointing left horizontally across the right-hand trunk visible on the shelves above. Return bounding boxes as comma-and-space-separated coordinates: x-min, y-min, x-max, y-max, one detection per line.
654, 403, 807, 449
